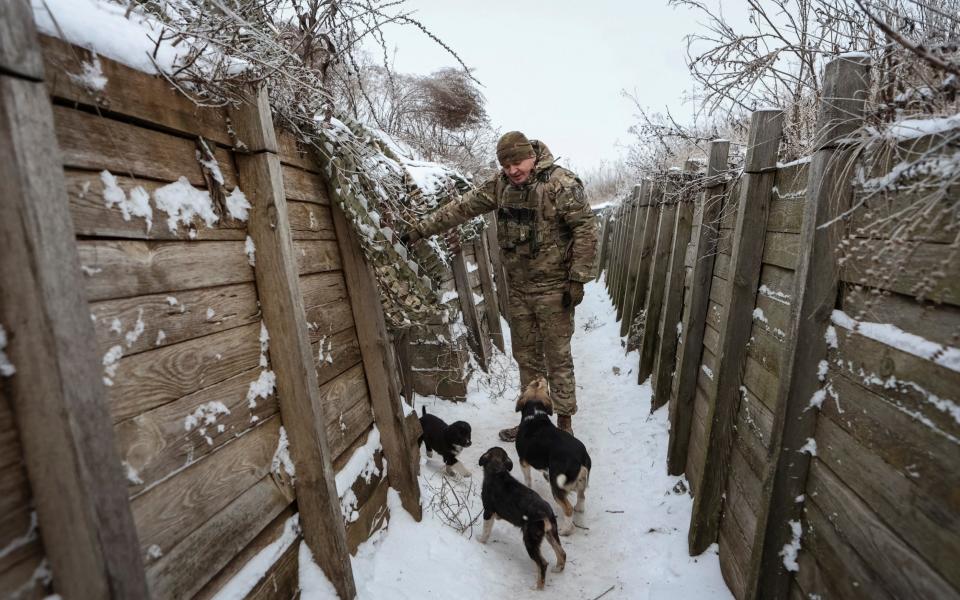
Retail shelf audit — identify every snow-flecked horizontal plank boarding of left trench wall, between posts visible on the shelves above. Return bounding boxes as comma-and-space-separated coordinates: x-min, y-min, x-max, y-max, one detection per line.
11, 38, 418, 598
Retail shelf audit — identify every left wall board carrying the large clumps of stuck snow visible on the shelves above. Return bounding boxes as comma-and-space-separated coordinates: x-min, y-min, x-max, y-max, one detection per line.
64, 169, 247, 241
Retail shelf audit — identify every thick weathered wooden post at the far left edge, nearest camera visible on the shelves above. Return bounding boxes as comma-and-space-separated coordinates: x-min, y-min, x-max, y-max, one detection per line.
0, 0, 148, 599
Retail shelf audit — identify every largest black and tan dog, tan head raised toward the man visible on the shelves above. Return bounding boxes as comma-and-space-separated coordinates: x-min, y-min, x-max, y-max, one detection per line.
517, 377, 591, 535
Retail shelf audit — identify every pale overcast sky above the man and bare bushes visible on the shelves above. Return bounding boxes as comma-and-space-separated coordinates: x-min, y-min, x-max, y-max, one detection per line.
374, 0, 744, 176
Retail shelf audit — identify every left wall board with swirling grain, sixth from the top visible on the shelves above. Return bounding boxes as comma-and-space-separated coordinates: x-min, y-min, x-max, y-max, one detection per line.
107, 323, 260, 422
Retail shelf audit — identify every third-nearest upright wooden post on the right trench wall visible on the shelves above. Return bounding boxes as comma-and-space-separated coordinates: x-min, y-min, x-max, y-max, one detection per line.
667, 140, 730, 475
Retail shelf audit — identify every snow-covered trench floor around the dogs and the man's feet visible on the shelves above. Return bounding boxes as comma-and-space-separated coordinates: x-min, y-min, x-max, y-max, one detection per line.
344, 283, 731, 600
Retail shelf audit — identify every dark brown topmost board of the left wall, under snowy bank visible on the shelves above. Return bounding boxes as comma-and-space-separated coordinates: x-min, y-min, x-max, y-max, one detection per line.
40, 35, 233, 146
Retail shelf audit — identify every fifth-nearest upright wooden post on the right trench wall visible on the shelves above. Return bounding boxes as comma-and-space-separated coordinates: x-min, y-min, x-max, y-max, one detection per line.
637, 176, 679, 383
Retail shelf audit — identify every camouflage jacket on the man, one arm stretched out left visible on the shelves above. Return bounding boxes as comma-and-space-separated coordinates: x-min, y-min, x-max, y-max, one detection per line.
417, 140, 597, 293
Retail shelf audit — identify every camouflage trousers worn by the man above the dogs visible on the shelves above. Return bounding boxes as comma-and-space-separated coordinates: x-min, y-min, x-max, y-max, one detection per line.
509, 290, 577, 415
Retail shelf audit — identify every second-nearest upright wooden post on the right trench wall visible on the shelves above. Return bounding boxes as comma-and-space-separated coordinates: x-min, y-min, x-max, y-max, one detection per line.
687, 110, 783, 555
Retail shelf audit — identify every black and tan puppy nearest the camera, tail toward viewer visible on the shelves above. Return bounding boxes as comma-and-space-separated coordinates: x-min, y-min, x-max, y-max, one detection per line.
477, 446, 567, 590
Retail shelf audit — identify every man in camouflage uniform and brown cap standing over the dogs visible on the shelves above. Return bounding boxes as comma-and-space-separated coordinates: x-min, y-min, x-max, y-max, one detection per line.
405, 131, 597, 441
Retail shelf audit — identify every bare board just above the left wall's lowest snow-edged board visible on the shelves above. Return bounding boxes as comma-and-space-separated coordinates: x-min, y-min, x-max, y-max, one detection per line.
147, 475, 292, 599
